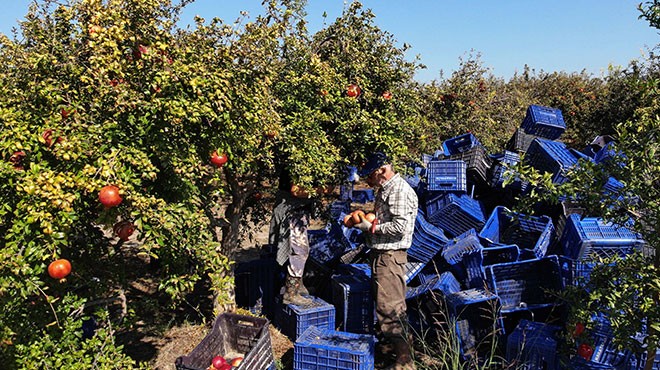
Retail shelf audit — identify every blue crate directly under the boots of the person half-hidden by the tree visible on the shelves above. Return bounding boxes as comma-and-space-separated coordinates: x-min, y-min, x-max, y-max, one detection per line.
275, 296, 336, 341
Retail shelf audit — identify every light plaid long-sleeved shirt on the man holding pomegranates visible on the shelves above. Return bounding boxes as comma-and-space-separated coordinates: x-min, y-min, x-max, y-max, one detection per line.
371, 174, 417, 250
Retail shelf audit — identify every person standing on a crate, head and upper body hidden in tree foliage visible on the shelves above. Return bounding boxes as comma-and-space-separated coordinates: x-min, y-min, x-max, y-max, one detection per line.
268, 170, 314, 306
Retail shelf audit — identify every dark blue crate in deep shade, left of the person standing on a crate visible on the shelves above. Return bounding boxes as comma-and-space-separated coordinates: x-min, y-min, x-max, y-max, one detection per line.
234, 258, 280, 318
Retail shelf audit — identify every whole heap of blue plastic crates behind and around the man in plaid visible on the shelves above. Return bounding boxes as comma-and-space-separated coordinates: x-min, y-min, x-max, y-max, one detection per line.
224, 106, 644, 369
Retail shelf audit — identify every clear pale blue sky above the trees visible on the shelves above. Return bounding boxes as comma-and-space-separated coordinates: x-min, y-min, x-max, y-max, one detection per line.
0, 0, 660, 82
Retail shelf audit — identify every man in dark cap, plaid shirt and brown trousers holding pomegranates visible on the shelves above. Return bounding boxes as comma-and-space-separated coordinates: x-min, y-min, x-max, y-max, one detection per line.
355, 152, 418, 370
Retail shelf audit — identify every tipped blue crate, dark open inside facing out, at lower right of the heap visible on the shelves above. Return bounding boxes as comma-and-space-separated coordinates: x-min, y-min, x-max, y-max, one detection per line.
485, 256, 564, 313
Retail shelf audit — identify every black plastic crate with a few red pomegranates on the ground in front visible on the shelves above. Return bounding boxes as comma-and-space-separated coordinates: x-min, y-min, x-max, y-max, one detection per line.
175, 313, 274, 370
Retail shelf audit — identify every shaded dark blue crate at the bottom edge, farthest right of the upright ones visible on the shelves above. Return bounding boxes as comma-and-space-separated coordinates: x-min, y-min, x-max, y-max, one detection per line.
506, 319, 562, 370
